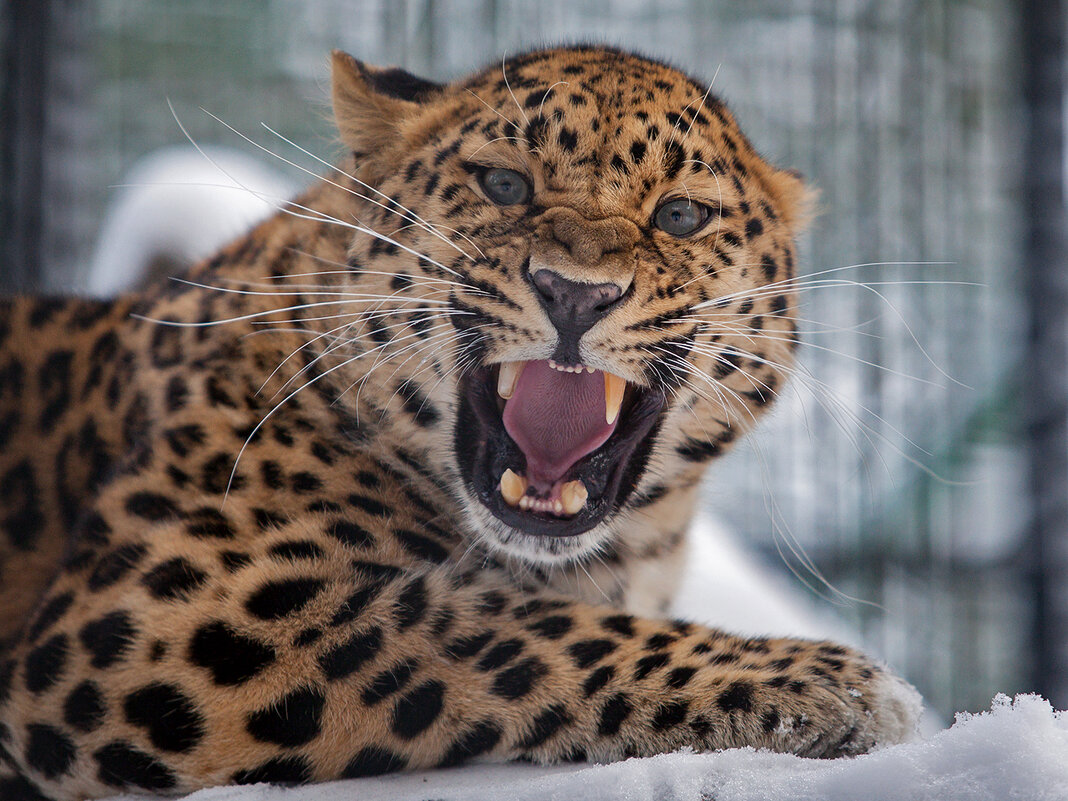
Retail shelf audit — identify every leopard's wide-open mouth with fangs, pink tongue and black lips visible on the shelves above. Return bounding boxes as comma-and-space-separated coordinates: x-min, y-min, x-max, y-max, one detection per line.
455, 360, 666, 537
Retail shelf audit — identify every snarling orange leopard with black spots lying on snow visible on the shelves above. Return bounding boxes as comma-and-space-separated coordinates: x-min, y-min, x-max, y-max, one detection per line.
0, 45, 921, 801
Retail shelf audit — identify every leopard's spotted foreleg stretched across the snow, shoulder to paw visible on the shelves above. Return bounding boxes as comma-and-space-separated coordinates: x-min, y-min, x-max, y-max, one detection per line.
0, 463, 912, 799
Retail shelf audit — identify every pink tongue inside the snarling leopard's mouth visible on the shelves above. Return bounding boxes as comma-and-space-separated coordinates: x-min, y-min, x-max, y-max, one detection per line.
504, 361, 618, 493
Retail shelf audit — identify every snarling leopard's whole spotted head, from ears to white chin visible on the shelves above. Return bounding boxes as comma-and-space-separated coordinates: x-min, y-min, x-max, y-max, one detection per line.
335, 48, 803, 562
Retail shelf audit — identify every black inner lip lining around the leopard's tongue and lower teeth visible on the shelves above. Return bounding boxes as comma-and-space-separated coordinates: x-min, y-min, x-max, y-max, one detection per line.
454, 365, 666, 537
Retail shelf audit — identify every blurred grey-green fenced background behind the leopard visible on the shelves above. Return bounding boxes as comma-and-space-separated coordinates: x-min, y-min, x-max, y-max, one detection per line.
0, 0, 1068, 716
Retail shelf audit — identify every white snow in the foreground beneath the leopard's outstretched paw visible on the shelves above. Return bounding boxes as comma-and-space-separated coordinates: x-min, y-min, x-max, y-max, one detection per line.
106, 695, 1068, 801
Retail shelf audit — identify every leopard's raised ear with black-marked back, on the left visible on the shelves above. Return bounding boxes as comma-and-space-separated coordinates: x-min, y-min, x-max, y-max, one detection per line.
331, 50, 442, 183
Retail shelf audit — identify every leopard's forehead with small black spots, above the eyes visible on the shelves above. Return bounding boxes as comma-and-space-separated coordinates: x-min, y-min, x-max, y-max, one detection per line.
454, 47, 758, 211
